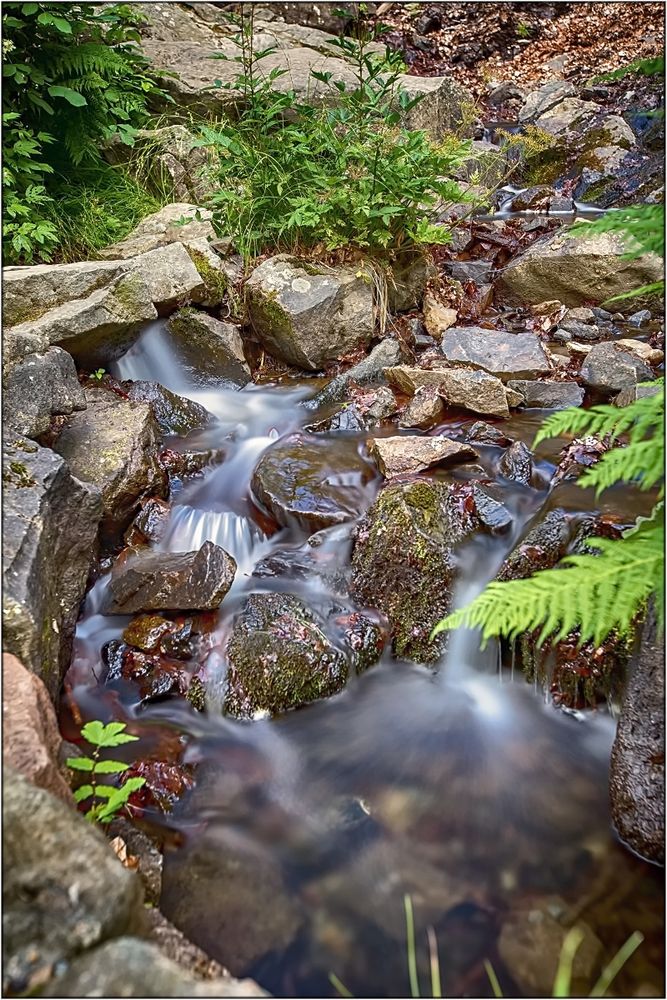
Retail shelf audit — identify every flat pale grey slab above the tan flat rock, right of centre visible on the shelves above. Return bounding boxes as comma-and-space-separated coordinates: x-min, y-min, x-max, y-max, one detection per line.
440, 326, 551, 379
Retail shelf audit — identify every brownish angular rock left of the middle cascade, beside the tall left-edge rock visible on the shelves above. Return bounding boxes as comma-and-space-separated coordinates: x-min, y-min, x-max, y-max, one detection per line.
54, 387, 167, 540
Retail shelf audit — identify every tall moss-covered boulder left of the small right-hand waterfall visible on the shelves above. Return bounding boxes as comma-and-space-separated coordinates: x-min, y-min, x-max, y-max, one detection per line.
352, 480, 479, 663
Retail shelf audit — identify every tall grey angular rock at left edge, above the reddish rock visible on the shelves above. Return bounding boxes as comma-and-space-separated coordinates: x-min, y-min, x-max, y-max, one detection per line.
2, 442, 102, 699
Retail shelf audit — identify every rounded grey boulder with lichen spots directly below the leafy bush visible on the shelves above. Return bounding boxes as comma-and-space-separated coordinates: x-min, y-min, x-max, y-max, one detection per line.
245, 255, 375, 371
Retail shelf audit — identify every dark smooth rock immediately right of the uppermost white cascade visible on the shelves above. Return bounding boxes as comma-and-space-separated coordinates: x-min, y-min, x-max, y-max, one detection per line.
167, 308, 250, 385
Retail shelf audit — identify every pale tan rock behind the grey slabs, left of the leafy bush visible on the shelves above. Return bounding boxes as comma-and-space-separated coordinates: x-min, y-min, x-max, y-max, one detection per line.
100, 200, 216, 260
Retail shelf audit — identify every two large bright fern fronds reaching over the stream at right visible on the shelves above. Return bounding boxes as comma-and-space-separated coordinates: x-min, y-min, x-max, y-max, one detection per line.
434, 385, 665, 645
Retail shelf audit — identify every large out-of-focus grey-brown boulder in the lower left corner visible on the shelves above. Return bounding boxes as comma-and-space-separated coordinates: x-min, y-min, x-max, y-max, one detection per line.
2, 769, 142, 995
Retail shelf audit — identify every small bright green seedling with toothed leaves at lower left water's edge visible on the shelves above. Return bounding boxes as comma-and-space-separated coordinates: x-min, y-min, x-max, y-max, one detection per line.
67, 720, 146, 823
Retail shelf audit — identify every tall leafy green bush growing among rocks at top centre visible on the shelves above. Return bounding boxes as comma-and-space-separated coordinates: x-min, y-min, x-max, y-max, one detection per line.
201, 5, 469, 258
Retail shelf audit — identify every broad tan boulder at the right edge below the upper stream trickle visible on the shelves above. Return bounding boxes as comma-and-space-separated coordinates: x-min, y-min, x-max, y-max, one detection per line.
500, 230, 663, 306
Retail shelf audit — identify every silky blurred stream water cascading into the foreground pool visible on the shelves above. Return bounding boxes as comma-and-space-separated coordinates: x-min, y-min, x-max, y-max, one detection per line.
61, 323, 664, 997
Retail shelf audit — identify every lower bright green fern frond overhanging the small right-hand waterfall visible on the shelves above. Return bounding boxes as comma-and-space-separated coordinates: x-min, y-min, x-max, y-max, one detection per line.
433, 504, 665, 645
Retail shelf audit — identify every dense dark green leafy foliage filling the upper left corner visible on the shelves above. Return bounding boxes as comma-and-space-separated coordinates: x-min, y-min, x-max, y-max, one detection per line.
2, 2, 169, 263
